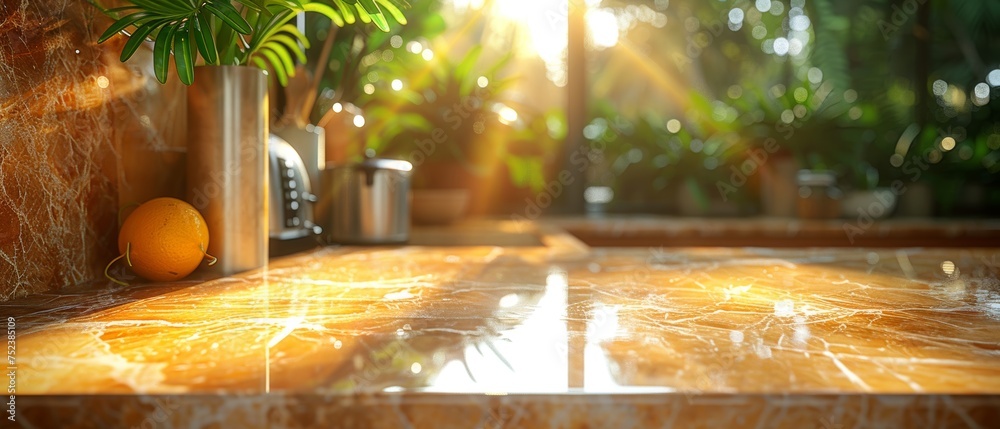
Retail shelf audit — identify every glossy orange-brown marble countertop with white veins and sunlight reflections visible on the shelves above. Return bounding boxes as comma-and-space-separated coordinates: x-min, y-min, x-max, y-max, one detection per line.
7, 222, 1000, 429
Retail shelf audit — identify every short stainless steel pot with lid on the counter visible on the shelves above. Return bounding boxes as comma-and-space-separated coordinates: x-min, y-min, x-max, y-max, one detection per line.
316, 158, 413, 244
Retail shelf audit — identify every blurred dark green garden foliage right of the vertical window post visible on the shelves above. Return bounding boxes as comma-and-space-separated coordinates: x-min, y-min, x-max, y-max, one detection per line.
589, 0, 1000, 213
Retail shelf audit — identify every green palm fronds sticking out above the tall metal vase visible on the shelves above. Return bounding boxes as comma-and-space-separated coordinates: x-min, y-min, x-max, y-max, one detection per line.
93, 0, 407, 85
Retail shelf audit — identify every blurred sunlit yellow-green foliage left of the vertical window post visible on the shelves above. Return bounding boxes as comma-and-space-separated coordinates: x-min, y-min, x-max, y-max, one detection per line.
310, 0, 566, 191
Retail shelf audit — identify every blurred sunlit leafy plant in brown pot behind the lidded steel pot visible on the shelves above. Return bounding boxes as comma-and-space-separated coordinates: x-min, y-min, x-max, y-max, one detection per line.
320, 45, 540, 223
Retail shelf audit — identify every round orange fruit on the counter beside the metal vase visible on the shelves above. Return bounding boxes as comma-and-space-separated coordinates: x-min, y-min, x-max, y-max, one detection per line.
109, 197, 215, 282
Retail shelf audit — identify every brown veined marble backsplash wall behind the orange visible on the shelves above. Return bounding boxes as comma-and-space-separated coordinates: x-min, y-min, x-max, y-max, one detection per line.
0, 0, 186, 301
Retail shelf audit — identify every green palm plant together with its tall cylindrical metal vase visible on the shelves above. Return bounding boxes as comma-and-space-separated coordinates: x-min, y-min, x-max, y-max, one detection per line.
91, 0, 399, 275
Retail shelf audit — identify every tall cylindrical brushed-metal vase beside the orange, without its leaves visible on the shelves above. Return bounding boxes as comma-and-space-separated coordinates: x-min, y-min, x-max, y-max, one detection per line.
187, 66, 268, 275
